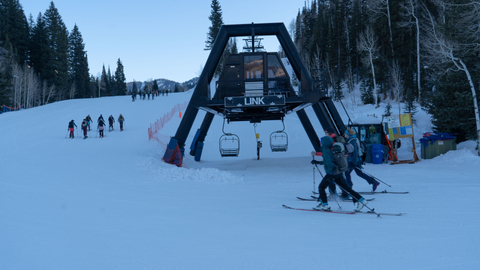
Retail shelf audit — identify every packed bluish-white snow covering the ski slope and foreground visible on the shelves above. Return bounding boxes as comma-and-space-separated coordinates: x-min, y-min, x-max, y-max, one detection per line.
0, 88, 480, 270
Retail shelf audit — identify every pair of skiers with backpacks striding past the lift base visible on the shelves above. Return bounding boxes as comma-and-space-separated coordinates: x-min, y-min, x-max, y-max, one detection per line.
311, 128, 380, 211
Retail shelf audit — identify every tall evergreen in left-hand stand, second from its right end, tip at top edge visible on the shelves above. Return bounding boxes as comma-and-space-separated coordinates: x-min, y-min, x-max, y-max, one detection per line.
43, 2, 69, 100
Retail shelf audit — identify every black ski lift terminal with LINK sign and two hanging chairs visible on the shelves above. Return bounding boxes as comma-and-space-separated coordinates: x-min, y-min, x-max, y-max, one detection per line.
163, 23, 345, 166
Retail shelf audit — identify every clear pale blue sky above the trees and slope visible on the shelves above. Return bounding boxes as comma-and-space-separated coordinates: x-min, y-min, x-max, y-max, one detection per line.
20, 0, 305, 82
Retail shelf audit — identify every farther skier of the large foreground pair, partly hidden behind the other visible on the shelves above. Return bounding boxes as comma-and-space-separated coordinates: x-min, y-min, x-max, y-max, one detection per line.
345, 129, 380, 191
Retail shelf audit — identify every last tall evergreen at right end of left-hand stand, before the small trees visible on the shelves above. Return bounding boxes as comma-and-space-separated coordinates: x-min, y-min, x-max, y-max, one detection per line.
69, 24, 91, 98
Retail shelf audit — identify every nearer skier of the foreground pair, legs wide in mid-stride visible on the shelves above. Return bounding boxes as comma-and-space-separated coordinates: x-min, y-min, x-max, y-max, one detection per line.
311, 136, 368, 211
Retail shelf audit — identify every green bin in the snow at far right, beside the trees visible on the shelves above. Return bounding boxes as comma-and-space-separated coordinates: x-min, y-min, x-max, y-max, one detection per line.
420, 133, 457, 159
